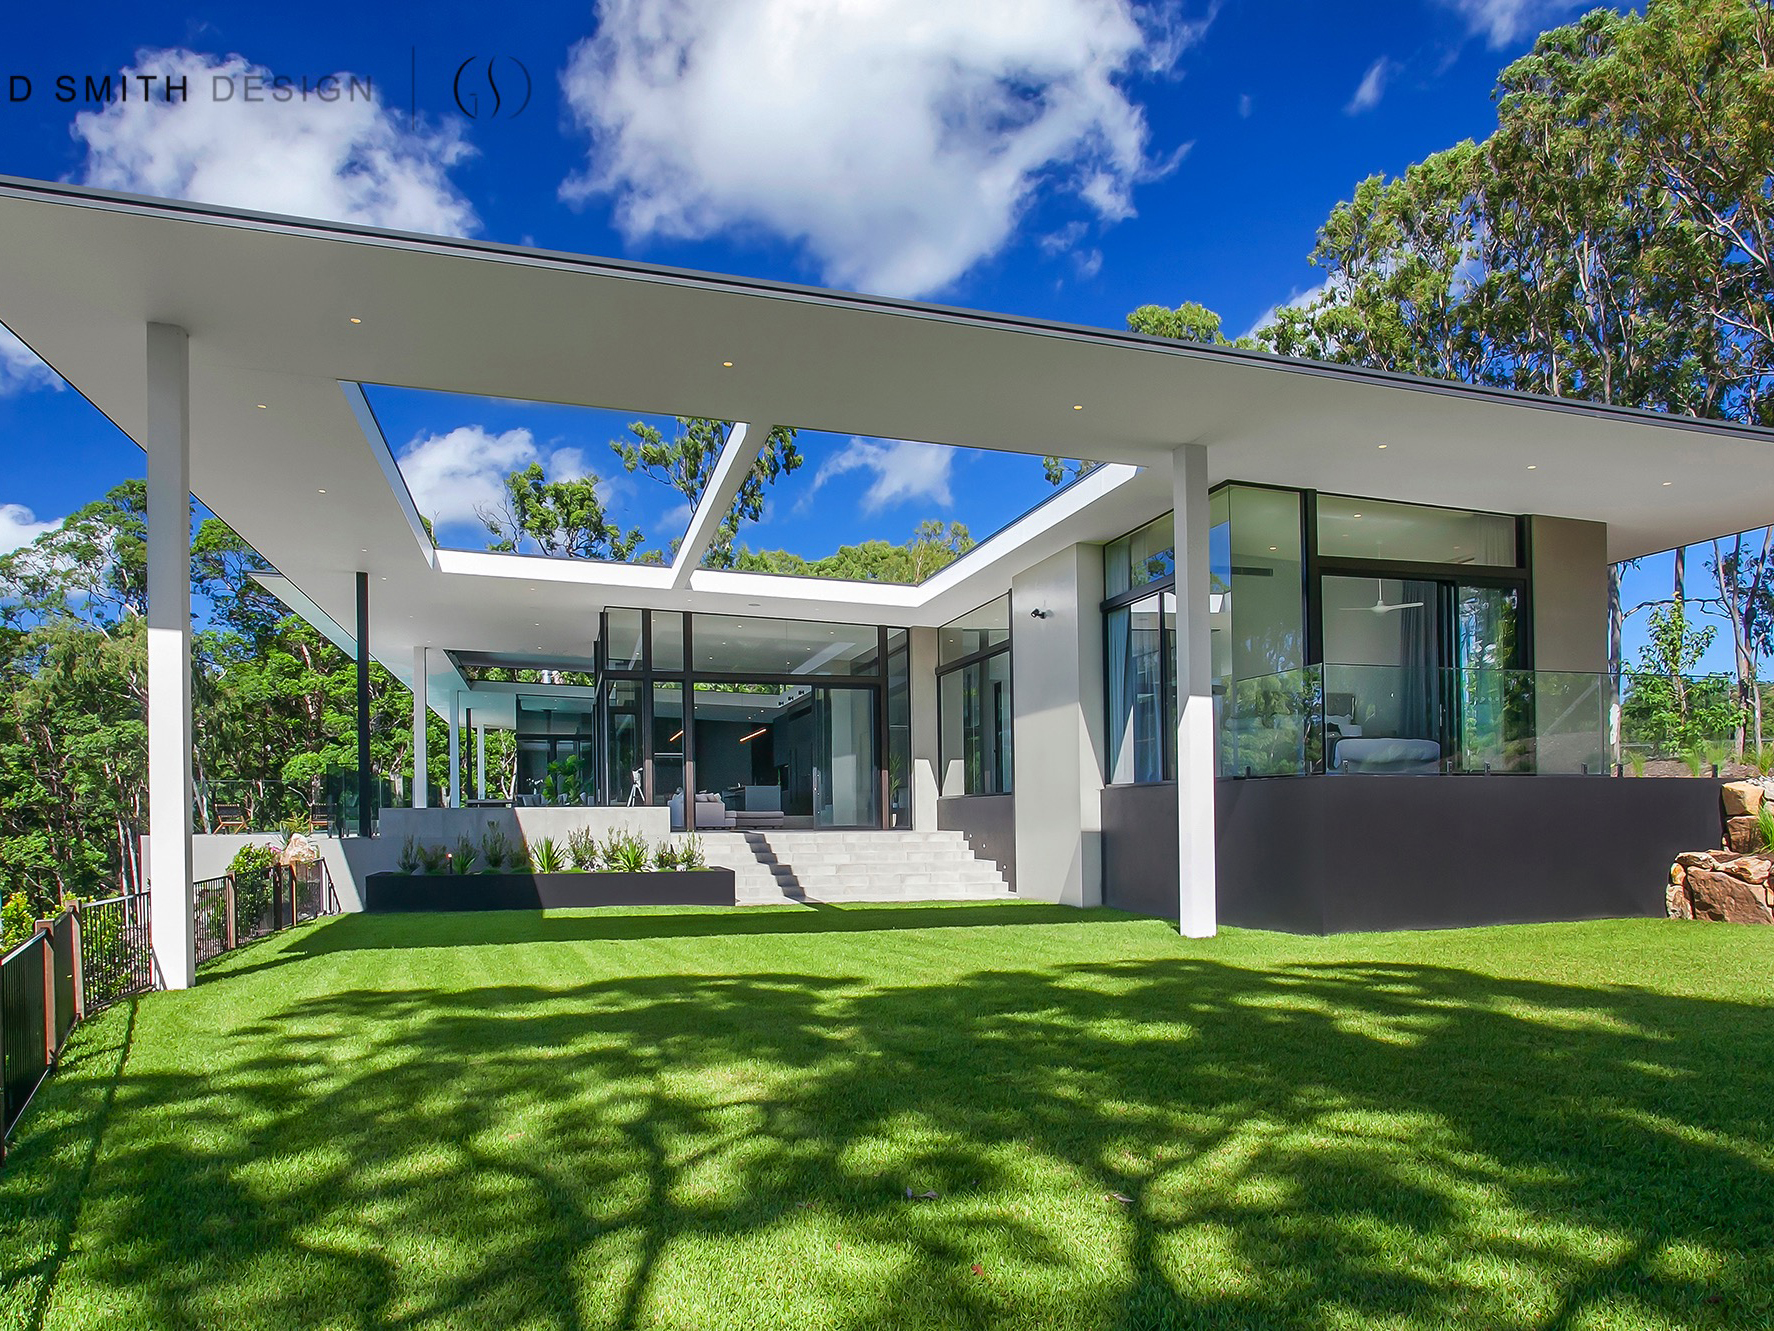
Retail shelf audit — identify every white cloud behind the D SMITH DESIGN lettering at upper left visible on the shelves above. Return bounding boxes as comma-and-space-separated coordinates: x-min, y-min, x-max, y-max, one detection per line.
73, 50, 479, 236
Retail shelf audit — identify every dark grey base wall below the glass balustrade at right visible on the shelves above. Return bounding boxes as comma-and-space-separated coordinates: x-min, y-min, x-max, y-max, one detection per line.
1102, 776, 1721, 933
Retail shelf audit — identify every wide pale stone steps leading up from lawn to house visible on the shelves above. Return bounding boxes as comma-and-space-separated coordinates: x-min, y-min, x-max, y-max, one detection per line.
701, 831, 1017, 905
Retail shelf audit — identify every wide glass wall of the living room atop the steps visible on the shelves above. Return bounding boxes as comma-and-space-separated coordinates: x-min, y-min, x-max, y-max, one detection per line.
603, 609, 912, 829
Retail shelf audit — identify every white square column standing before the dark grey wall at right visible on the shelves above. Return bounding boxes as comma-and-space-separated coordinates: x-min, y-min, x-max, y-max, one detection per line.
1171, 444, 1219, 939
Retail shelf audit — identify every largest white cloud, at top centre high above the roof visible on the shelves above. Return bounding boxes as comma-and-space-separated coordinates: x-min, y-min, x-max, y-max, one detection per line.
562, 0, 1212, 295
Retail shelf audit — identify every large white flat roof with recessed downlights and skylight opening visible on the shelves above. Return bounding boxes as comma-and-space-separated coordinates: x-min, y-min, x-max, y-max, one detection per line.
0, 177, 1774, 688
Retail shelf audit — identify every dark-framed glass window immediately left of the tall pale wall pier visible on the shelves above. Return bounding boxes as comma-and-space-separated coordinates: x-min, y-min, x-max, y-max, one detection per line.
937, 596, 1015, 797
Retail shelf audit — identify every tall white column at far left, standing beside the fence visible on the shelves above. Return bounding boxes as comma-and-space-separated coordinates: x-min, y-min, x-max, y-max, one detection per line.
142, 323, 197, 988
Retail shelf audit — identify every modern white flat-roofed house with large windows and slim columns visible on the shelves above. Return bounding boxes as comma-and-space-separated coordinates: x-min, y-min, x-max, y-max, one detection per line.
0, 179, 1774, 985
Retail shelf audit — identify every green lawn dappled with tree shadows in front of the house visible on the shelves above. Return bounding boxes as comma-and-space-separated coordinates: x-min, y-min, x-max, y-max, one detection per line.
0, 905, 1774, 1331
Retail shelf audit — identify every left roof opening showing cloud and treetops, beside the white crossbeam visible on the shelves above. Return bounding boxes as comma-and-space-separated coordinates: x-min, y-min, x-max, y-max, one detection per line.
360, 383, 731, 564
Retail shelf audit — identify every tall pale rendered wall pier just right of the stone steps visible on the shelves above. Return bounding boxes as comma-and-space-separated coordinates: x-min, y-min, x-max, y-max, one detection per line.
1009, 545, 1103, 905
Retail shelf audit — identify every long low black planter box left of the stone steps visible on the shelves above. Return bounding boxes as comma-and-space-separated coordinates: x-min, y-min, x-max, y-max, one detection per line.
364, 870, 738, 912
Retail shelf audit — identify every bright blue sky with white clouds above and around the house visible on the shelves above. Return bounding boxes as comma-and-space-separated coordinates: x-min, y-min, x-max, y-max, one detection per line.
0, 0, 1728, 667
